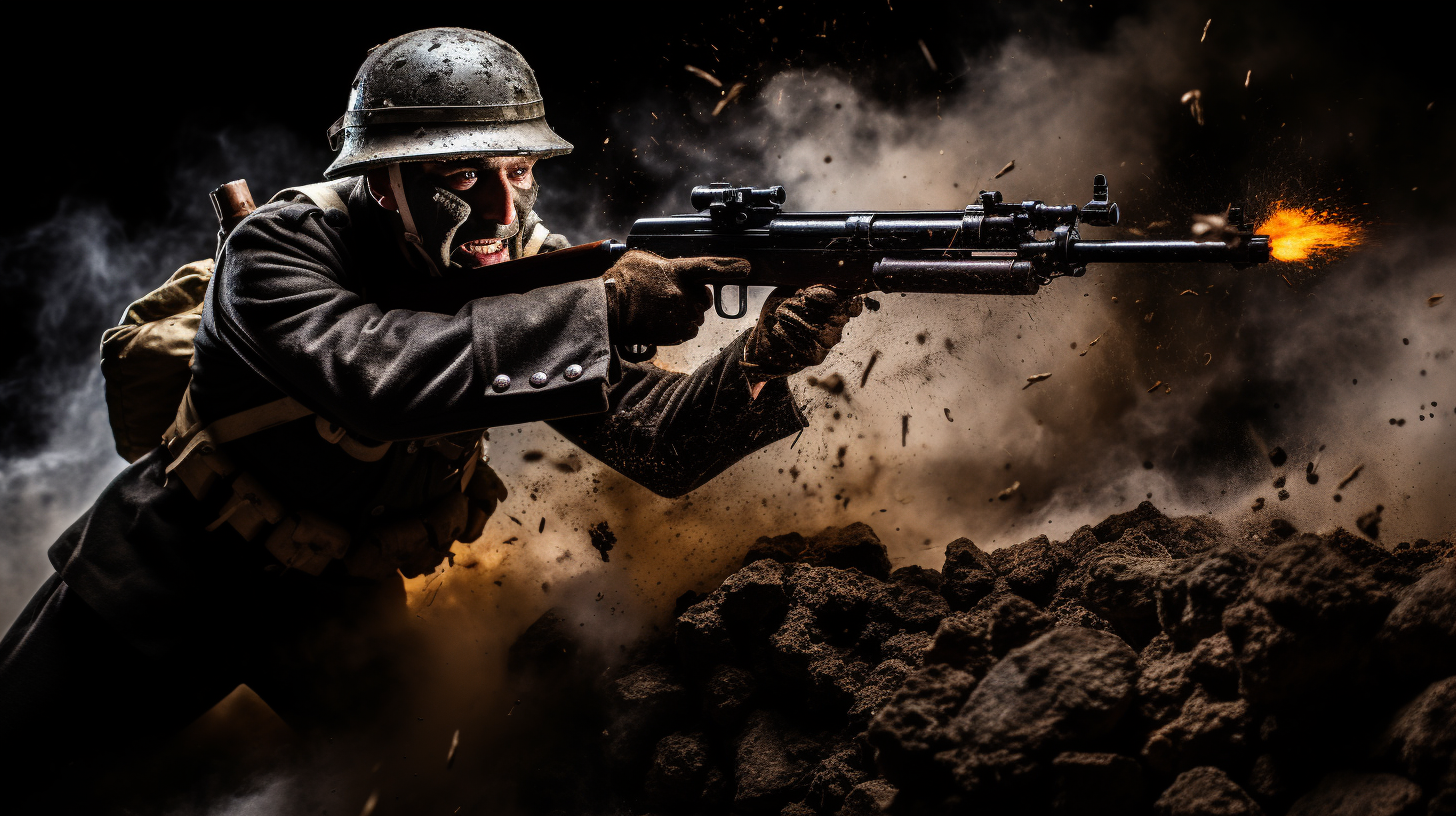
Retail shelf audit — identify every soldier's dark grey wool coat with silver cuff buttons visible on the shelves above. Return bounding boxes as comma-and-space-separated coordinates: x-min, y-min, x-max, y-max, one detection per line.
51, 178, 804, 651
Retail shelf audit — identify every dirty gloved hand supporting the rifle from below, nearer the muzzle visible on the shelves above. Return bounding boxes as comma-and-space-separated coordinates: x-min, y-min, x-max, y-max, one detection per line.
743, 284, 865, 382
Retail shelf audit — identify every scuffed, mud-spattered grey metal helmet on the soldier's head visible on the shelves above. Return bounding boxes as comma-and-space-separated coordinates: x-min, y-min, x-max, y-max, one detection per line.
323, 28, 571, 179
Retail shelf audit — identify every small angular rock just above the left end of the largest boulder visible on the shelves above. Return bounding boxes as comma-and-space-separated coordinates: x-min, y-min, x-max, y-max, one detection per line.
925, 593, 1053, 675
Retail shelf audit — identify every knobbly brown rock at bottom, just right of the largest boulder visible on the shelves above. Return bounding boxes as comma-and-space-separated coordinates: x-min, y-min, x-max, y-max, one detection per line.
1143, 688, 1254, 774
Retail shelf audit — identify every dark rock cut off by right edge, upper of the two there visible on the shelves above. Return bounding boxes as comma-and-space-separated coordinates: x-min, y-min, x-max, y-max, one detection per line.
1377, 562, 1456, 680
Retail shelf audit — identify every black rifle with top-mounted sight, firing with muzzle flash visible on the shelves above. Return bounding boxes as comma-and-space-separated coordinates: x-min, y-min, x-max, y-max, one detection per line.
396, 175, 1270, 361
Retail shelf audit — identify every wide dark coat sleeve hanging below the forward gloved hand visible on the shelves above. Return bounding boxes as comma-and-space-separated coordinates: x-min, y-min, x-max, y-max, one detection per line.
552, 332, 805, 497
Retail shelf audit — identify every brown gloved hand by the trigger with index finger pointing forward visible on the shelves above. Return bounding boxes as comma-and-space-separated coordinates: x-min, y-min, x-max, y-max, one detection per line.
601, 249, 748, 345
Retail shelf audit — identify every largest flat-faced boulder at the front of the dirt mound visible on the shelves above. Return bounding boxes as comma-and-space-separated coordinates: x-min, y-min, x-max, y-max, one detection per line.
938, 627, 1137, 793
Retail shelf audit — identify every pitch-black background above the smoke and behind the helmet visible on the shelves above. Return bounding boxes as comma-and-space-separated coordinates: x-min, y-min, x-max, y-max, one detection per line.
0, 0, 1452, 450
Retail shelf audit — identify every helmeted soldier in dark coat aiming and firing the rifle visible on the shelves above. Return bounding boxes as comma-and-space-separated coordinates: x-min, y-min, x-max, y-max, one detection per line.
0, 28, 860, 791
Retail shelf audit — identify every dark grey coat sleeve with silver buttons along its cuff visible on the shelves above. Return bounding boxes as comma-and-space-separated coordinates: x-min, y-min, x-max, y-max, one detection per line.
202, 203, 619, 440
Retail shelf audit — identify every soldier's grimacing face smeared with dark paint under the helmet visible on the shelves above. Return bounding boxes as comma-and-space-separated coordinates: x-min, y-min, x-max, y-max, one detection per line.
419, 156, 536, 268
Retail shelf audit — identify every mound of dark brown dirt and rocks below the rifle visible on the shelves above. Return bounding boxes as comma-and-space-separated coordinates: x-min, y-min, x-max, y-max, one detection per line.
515, 503, 1456, 816
